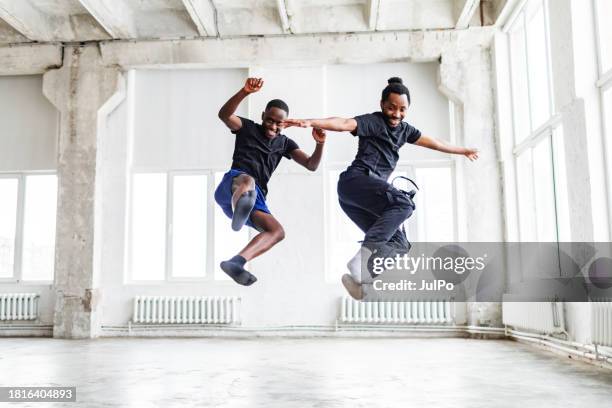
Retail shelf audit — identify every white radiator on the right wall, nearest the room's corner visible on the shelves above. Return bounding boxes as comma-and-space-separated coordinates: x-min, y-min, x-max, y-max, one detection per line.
502, 301, 565, 334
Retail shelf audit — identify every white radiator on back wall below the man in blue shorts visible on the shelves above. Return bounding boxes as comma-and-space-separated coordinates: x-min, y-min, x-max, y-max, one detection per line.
132, 296, 240, 324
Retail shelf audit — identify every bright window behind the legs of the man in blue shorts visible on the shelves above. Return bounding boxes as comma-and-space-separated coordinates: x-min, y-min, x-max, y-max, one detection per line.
128, 171, 249, 282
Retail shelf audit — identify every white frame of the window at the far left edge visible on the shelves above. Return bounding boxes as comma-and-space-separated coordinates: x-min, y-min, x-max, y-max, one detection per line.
0, 170, 59, 285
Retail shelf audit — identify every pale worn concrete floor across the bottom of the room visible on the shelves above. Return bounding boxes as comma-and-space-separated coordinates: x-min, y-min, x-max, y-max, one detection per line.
0, 338, 612, 408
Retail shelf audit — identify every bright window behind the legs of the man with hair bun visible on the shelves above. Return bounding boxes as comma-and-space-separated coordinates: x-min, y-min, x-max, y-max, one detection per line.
325, 161, 456, 283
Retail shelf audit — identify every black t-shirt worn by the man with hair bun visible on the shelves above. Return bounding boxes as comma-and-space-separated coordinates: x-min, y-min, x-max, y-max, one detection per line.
349, 112, 421, 180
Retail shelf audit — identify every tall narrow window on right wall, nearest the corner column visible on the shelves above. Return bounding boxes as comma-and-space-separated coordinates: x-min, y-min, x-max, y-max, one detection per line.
506, 0, 569, 242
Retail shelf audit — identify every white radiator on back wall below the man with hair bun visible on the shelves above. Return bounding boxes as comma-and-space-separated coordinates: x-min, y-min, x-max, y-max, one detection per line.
340, 296, 455, 324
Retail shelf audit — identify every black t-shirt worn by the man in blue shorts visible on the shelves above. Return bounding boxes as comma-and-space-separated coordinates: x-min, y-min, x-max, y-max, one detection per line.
232, 117, 299, 195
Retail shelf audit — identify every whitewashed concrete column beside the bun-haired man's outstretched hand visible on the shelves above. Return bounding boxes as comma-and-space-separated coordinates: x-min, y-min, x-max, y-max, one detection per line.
440, 43, 504, 326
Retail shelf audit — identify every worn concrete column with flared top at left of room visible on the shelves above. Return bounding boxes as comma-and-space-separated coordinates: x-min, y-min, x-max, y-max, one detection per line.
43, 45, 120, 338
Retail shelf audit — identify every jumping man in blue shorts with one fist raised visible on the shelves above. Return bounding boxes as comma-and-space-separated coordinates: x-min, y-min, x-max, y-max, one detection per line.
215, 78, 326, 286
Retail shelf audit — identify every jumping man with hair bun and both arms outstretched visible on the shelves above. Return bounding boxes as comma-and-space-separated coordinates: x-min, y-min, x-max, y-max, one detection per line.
284, 77, 478, 299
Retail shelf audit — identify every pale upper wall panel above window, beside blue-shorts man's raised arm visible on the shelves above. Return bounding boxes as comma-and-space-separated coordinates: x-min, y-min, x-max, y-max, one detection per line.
133, 69, 247, 169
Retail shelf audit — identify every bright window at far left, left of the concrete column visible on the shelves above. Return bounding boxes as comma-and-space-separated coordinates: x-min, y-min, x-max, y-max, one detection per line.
0, 174, 57, 282
